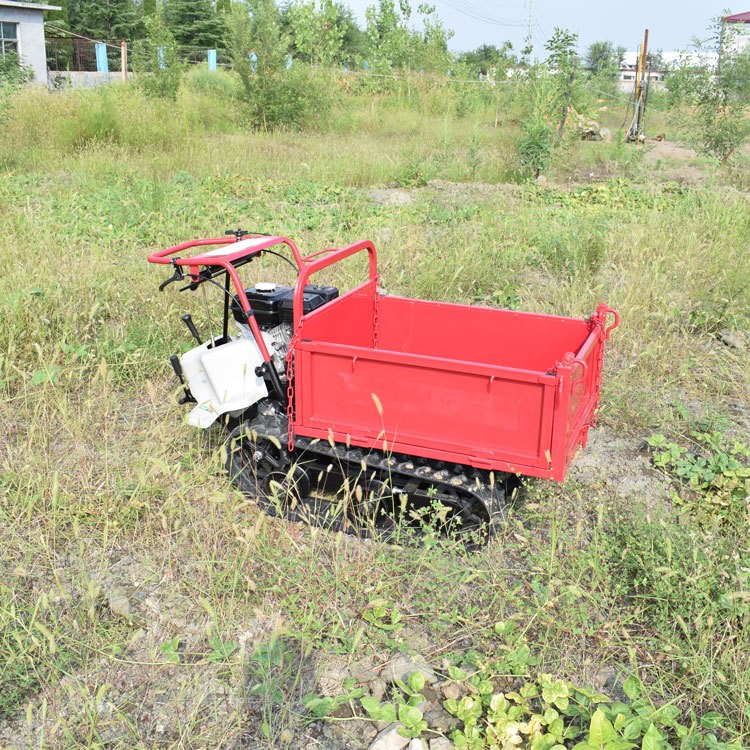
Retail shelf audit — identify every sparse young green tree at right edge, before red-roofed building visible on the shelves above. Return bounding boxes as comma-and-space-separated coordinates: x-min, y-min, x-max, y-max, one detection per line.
667, 18, 750, 164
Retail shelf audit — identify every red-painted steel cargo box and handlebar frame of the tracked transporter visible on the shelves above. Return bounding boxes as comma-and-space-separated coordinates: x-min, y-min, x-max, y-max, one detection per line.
148, 236, 619, 480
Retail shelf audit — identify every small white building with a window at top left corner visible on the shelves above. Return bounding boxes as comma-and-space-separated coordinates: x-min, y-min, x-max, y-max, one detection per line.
0, 0, 60, 84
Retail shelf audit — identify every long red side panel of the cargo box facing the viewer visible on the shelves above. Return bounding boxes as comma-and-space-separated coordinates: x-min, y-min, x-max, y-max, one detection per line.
295, 340, 556, 476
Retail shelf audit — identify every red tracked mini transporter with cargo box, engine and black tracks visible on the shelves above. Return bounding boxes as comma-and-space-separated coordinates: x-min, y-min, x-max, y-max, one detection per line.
148, 230, 619, 538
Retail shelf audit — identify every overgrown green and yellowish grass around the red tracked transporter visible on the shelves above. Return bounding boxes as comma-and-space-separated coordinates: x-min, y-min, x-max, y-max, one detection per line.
0, 75, 750, 748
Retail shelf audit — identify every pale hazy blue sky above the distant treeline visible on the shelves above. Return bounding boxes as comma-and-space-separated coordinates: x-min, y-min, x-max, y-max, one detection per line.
344, 0, 750, 59
